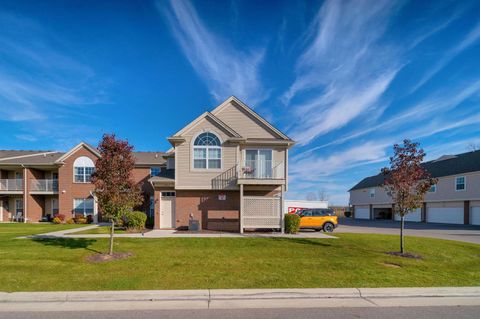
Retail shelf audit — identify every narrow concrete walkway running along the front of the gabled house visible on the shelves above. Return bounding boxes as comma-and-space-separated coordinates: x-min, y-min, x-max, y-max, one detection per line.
27, 225, 336, 239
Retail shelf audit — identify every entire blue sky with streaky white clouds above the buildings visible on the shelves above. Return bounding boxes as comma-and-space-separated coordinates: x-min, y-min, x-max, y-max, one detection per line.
0, 0, 480, 204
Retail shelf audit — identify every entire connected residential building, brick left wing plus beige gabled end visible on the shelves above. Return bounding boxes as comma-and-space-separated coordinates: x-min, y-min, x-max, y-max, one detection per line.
0, 97, 294, 232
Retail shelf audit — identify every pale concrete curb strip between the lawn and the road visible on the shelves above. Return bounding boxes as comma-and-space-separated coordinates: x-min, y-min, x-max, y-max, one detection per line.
0, 287, 480, 313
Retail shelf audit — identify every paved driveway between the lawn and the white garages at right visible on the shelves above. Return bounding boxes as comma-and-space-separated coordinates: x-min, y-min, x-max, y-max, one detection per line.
334, 218, 480, 244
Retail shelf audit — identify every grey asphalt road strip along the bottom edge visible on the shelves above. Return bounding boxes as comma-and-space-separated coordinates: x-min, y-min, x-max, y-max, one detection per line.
0, 306, 480, 319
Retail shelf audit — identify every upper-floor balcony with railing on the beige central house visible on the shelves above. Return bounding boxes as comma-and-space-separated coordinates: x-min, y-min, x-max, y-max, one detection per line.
238, 159, 285, 185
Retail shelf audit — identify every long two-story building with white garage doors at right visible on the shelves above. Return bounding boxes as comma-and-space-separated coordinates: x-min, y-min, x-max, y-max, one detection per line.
349, 151, 480, 225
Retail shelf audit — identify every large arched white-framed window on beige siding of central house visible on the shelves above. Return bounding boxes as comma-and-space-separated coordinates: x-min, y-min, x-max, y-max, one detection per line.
193, 132, 222, 169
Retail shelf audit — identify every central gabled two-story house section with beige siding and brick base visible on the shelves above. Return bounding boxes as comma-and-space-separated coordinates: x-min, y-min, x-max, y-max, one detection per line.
150, 96, 294, 232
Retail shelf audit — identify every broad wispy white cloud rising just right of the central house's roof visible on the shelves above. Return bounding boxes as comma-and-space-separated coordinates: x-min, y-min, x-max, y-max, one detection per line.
282, 1, 402, 145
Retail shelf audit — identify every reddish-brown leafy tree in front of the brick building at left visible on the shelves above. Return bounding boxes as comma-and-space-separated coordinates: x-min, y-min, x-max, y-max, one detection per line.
92, 134, 143, 255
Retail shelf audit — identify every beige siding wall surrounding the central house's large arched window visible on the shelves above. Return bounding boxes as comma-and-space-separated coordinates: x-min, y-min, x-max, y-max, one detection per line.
175, 119, 237, 189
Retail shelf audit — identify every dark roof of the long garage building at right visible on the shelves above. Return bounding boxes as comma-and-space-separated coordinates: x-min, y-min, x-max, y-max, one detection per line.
350, 150, 480, 191
